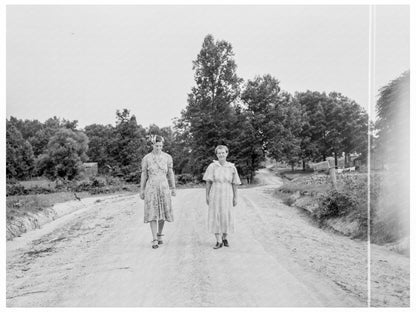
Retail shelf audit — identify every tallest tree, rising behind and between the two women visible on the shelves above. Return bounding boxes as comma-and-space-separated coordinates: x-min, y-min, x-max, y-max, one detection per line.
178, 35, 242, 177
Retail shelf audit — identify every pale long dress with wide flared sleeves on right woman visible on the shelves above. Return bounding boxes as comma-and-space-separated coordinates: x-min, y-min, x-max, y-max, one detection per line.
203, 160, 241, 233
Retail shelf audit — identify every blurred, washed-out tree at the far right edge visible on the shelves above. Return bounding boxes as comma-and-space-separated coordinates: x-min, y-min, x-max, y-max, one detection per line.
375, 71, 410, 240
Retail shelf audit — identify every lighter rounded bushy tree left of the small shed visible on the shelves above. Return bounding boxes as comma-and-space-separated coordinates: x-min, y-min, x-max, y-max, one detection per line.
37, 128, 88, 180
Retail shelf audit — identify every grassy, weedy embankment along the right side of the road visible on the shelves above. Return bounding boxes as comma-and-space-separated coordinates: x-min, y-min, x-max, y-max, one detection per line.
274, 169, 409, 254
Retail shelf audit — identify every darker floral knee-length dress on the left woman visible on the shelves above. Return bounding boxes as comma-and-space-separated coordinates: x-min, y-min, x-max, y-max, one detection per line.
142, 152, 173, 223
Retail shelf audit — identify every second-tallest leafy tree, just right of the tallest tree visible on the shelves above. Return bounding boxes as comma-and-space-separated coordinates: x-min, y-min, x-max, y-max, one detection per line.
241, 75, 301, 174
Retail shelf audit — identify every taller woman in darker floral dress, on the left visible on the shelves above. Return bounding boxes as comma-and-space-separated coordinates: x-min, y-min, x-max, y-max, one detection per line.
140, 136, 176, 249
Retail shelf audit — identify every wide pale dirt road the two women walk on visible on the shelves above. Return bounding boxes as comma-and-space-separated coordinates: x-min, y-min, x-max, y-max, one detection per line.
6, 171, 408, 307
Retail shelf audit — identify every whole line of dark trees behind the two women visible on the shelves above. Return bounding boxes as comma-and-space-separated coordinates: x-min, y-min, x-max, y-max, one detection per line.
6, 35, 406, 182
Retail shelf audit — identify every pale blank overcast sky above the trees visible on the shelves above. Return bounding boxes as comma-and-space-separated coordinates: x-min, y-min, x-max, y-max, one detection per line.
6, 5, 410, 127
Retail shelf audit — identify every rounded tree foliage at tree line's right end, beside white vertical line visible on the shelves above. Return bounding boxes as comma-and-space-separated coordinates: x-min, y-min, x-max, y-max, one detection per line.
295, 91, 368, 166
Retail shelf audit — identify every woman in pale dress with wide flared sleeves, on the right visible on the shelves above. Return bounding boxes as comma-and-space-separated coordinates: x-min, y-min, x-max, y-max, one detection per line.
203, 145, 241, 249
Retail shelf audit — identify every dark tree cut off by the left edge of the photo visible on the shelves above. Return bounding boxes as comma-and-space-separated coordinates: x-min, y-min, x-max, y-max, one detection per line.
6, 121, 35, 179
